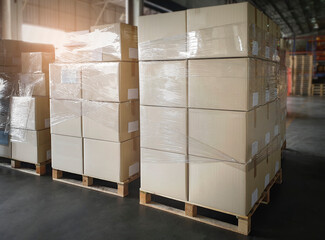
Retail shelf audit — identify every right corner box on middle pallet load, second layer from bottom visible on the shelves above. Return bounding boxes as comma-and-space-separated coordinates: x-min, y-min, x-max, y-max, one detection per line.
82, 101, 140, 142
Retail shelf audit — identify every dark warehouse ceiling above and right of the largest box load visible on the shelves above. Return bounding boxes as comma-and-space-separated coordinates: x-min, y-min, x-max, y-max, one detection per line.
144, 0, 325, 37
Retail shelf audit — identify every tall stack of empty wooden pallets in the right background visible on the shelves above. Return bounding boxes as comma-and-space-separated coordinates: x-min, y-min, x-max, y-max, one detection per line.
292, 55, 313, 96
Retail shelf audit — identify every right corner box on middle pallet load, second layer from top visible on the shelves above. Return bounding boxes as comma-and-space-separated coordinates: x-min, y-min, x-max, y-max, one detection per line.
82, 62, 139, 102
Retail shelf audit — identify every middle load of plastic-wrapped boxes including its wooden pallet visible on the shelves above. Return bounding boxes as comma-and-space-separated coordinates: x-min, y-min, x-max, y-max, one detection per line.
50, 23, 140, 196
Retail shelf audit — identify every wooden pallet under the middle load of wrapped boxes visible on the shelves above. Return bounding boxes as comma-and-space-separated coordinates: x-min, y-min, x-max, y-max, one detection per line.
52, 169, 140, 197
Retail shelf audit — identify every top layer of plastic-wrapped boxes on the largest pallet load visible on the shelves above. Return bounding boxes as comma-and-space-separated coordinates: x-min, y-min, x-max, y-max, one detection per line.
139, 3, 279, 61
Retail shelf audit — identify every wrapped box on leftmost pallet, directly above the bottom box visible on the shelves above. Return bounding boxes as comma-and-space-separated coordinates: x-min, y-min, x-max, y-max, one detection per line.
10, 97, 50, 130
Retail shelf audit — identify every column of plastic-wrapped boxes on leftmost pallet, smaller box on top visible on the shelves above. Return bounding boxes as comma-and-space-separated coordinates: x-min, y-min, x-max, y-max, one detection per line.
10, 52, 54, 164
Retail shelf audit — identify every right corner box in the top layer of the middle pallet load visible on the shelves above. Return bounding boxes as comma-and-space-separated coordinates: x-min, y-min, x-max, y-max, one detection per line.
89, 23, 138, 61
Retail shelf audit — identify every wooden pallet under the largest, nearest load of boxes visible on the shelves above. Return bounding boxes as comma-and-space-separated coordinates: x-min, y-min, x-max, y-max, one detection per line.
140, 169, 282, 235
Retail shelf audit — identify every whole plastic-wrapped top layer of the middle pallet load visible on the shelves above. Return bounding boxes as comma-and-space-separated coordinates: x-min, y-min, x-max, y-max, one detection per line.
56, 23, 138, 63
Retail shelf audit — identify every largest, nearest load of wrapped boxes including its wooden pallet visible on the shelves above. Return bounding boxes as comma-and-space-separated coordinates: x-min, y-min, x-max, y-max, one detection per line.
139, 3, 282, 234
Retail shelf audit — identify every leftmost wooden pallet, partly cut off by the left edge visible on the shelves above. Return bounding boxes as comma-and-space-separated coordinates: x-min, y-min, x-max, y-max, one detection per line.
0, 159, 51, 176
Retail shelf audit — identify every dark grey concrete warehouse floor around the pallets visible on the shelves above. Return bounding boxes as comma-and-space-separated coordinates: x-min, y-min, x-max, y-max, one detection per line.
0, 97, 325, 240
